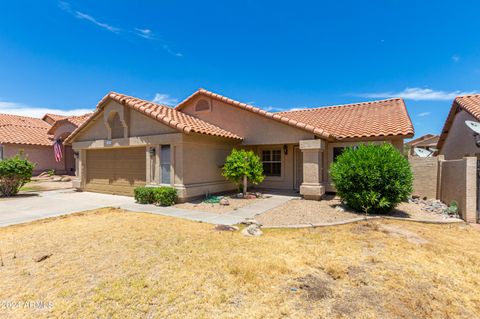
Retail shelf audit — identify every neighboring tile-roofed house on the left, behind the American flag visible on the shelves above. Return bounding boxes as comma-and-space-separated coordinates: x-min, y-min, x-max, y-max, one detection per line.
0, 114, 89, 175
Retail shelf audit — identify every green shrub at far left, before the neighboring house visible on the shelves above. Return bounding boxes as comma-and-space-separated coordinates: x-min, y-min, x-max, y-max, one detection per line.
0, 155, 35, 196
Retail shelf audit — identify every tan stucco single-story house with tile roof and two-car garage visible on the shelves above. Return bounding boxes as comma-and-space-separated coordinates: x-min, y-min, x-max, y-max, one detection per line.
65, 89, 414, 200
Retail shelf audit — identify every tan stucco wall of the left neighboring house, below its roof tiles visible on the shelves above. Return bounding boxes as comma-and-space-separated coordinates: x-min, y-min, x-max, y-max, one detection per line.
3, 144, 66, 175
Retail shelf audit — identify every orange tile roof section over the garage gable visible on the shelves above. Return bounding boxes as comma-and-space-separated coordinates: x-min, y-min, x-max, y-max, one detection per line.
65, 92, 243, 143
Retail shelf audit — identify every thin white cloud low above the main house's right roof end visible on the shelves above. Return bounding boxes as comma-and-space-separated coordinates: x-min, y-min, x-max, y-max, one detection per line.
358, 88, 476, 101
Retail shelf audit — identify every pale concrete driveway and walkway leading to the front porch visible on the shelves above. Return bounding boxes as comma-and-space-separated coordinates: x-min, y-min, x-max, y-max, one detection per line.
0, 189, 294, 227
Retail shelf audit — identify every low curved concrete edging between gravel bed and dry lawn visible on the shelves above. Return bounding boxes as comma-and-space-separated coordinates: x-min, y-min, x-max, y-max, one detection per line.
261, 216, 465, 229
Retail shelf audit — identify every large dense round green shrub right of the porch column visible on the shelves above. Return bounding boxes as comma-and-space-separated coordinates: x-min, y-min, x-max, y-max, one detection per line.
330, 143, 413, 214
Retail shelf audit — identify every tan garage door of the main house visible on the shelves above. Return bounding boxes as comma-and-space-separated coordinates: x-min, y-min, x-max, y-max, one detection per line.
85, 147, 146, 196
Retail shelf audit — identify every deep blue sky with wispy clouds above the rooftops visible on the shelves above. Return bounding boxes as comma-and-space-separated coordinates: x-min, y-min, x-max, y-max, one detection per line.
0, 0, 480, 136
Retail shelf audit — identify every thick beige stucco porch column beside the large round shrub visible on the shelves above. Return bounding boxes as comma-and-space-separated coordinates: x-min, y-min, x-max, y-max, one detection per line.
300, 139, 325, 200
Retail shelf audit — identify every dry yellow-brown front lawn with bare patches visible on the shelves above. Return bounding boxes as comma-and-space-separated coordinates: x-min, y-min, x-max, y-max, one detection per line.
0, 209, 480, 318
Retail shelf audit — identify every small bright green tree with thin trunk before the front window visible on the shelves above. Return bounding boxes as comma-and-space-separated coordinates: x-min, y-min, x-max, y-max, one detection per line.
222, 149, 265, 195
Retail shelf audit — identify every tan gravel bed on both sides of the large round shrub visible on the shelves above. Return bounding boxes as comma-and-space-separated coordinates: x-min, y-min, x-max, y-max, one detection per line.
255, 195, 460, 226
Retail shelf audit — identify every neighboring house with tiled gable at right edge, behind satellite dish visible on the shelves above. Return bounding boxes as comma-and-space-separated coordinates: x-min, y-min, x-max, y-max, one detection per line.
437, 94, 480, 160
